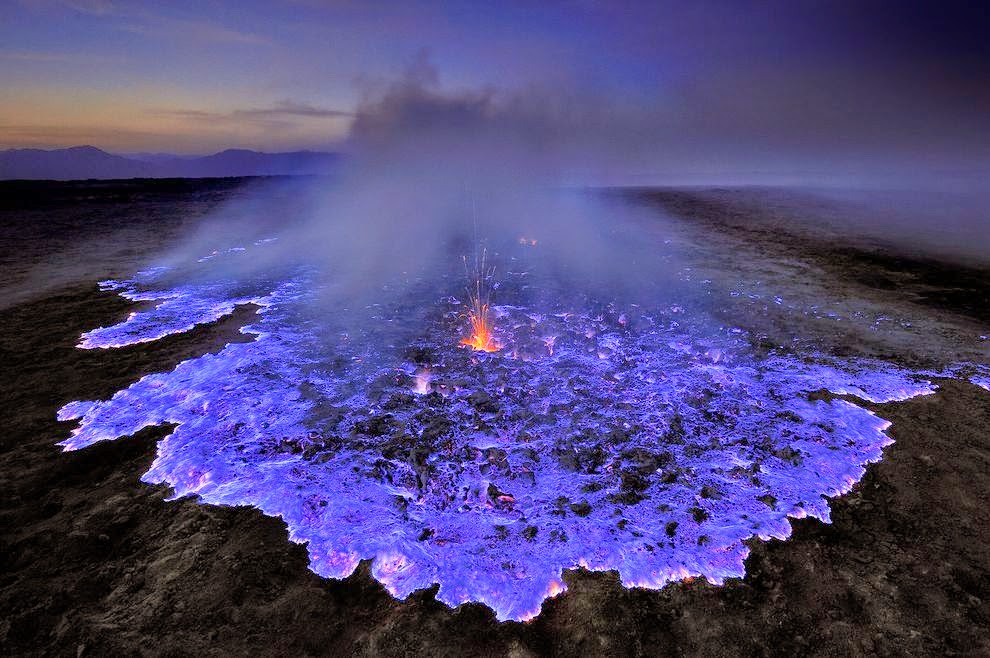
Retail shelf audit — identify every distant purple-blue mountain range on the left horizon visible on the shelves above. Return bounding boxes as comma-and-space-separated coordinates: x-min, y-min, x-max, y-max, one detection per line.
0, 146, 339, 180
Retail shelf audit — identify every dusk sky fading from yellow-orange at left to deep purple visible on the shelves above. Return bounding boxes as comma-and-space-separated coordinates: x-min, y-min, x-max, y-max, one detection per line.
0, 0, 990, 177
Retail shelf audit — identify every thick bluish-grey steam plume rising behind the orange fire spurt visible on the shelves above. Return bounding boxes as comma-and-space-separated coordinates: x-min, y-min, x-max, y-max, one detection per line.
163, 61, 688, 322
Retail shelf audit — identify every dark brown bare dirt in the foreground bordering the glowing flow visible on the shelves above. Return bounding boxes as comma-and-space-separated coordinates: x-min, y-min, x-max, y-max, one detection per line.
0, 181, 990, 656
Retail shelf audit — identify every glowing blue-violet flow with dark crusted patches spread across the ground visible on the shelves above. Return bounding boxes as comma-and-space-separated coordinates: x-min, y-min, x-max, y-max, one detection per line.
64, 243, 979, 620
